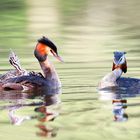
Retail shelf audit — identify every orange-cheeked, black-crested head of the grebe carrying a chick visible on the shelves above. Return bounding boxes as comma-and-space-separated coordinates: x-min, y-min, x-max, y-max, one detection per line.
34, 36, 63, 62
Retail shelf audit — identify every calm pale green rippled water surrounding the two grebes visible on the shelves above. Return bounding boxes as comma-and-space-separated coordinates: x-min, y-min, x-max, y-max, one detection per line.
0, 0, 140, 140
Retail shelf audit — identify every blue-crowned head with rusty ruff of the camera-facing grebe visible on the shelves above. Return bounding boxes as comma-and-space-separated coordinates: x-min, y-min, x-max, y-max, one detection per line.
112, 51, 127, 73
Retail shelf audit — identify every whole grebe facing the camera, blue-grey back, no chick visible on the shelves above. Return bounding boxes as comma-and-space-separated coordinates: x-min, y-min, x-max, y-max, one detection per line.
98, 51, 140, 91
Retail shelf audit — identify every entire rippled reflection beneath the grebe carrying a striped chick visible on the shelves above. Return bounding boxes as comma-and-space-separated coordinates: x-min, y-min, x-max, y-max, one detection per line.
0, 89, 61, 137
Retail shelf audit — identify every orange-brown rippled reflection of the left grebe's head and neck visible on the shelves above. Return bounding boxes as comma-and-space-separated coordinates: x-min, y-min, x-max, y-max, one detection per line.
32, 89, 60, 137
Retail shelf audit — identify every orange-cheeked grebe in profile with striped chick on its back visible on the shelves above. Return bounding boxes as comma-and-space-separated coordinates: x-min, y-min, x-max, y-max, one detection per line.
0, 37, 62, 90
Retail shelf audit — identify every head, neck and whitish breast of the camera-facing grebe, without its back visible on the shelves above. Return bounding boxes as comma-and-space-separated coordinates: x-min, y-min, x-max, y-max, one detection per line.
99, 51, 127, 89
